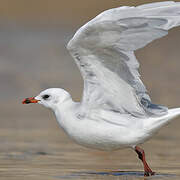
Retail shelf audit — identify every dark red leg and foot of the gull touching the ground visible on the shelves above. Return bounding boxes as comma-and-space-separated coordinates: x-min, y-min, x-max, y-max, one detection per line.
135, 146, 155, 176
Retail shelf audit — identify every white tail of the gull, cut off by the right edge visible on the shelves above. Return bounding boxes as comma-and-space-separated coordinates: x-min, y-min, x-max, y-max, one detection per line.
144, 108, 180, 132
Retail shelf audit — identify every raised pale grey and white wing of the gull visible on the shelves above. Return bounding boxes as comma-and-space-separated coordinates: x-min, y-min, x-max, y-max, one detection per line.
67, 1, 180, 116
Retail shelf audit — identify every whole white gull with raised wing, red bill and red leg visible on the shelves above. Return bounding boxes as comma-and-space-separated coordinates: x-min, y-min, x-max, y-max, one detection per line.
22, 1, 180, 176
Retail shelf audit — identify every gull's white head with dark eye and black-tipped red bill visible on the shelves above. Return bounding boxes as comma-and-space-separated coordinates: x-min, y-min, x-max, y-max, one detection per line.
22, 88, 70, 110
